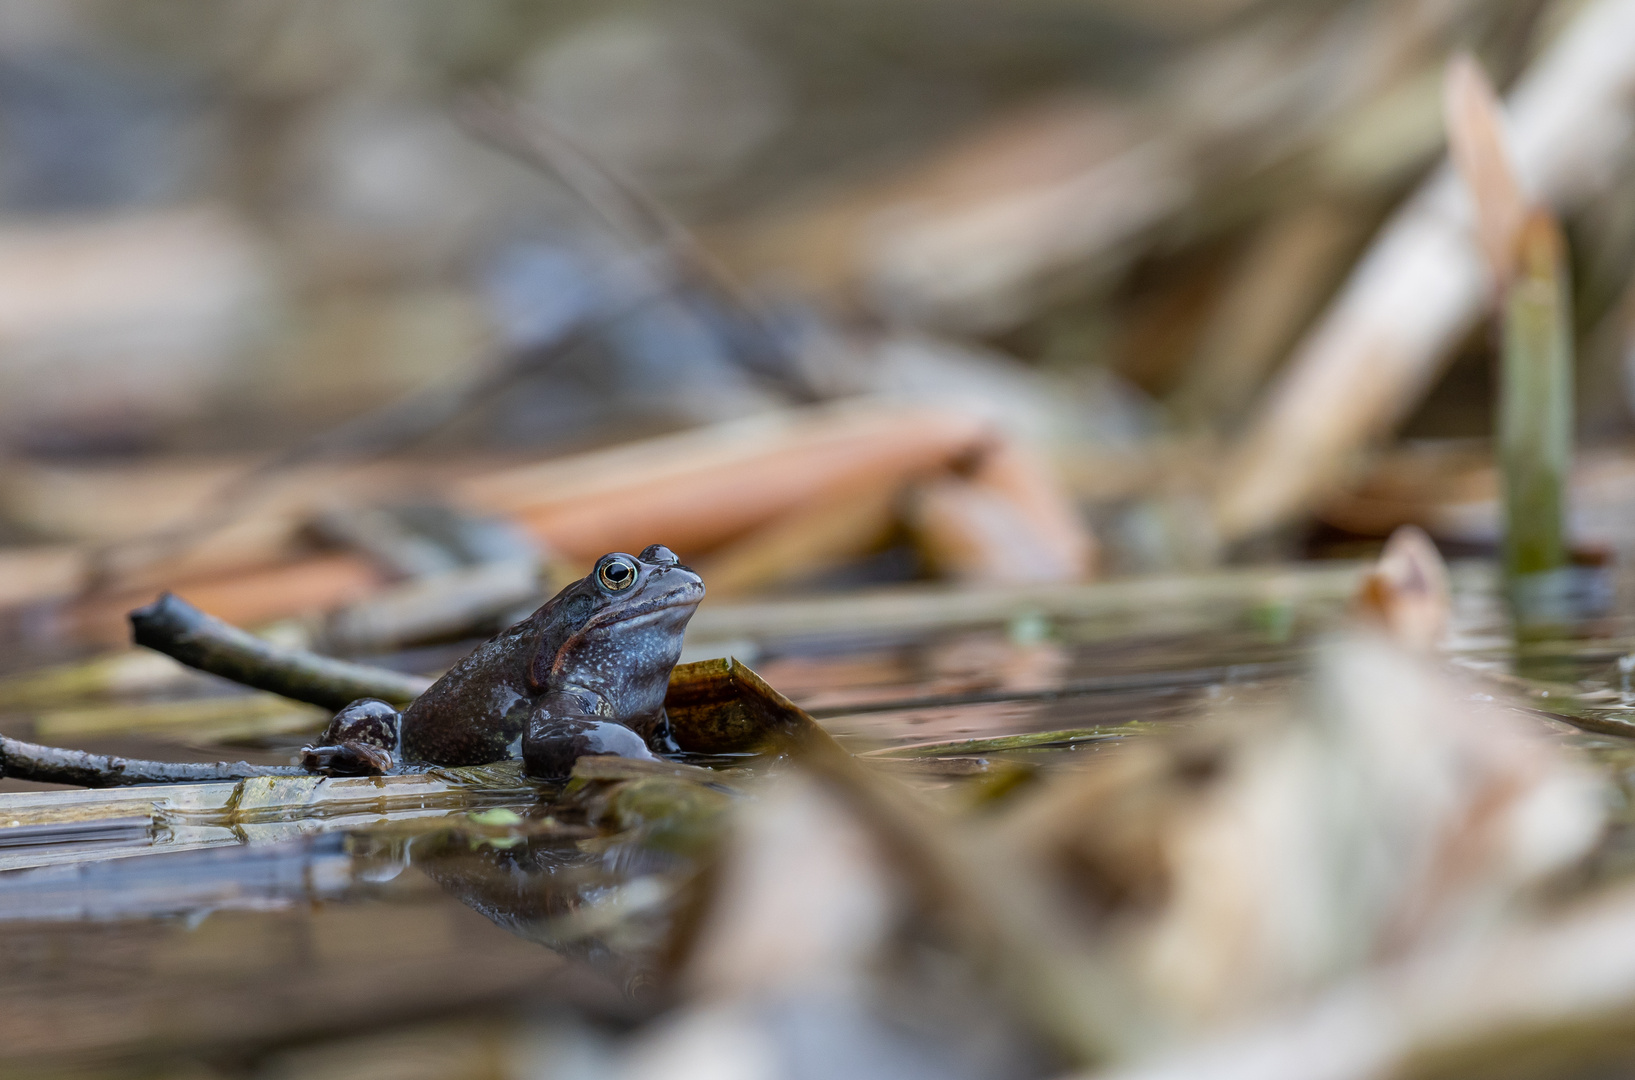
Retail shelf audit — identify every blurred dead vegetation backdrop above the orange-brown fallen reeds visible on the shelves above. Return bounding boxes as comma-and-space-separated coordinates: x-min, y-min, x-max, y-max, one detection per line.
0, 0, 1635, 584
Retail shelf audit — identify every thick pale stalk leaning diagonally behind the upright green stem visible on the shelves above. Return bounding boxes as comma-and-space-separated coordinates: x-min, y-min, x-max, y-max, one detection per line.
1213, 0, 1635, 539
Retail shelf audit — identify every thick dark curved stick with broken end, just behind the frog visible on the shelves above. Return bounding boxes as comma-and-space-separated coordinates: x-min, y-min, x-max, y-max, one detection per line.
128, 593, 432, 712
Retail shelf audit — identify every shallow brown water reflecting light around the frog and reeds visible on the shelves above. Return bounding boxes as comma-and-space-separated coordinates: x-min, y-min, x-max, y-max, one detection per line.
0, 565, 1635, 1075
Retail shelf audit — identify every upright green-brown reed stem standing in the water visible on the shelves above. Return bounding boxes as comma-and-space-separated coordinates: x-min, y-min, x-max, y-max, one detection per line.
1498, 211, 1573, 632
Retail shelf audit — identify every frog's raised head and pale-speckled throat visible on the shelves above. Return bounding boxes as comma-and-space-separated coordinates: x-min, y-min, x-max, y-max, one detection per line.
528, 544, 705, 716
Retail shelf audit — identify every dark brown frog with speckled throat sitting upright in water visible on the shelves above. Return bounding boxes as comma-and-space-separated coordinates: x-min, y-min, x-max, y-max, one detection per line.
301, 544, 705, 779
